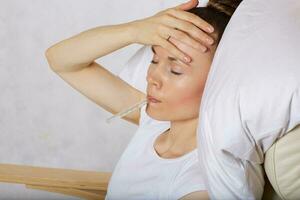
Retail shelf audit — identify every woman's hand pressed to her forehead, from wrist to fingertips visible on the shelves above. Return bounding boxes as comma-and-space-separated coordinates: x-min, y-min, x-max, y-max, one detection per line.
131, 0, 213, 62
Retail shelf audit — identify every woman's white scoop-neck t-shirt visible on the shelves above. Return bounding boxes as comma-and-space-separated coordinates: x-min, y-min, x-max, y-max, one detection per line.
105, 102, 206, 200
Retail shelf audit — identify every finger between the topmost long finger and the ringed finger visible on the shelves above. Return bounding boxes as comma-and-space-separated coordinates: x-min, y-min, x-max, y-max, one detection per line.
162, 15, 213, 46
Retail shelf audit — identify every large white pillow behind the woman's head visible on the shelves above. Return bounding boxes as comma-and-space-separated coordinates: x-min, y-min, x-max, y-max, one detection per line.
197, 0, 300, 199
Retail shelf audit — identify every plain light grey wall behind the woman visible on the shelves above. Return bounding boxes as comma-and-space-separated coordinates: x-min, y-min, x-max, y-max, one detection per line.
0, 0, 204, 200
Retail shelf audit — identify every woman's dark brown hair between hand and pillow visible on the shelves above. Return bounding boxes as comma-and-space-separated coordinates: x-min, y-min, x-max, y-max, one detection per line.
187, 0, 242, 44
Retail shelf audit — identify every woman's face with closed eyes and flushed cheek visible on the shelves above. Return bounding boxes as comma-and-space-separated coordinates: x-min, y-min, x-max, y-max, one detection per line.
146, 38, 216, 121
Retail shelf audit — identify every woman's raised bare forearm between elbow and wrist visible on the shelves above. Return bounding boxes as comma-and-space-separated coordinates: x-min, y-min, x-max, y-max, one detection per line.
46, 23, 134, 71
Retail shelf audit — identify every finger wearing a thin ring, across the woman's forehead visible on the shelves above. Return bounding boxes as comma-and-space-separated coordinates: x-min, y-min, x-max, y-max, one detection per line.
167, 27, 207, 52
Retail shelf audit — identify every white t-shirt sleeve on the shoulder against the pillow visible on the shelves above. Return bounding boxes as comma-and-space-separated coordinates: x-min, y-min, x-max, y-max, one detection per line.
170, 162, 206, 199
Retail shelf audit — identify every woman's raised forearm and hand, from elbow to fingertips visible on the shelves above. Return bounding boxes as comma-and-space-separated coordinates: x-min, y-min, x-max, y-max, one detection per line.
46, 0, 213, 71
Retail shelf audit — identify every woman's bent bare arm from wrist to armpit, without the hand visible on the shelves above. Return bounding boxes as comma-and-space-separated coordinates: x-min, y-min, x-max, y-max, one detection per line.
46, 24, 145, 125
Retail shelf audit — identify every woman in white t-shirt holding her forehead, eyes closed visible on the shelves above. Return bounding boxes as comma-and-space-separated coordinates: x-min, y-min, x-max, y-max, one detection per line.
46, 0, 240, 199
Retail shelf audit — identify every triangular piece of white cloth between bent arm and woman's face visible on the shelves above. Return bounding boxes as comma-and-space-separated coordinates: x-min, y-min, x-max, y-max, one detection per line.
117, 45, 153, 93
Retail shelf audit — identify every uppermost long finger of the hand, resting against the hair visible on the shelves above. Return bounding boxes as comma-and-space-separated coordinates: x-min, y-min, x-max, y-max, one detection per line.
166, 9, 214, 33
